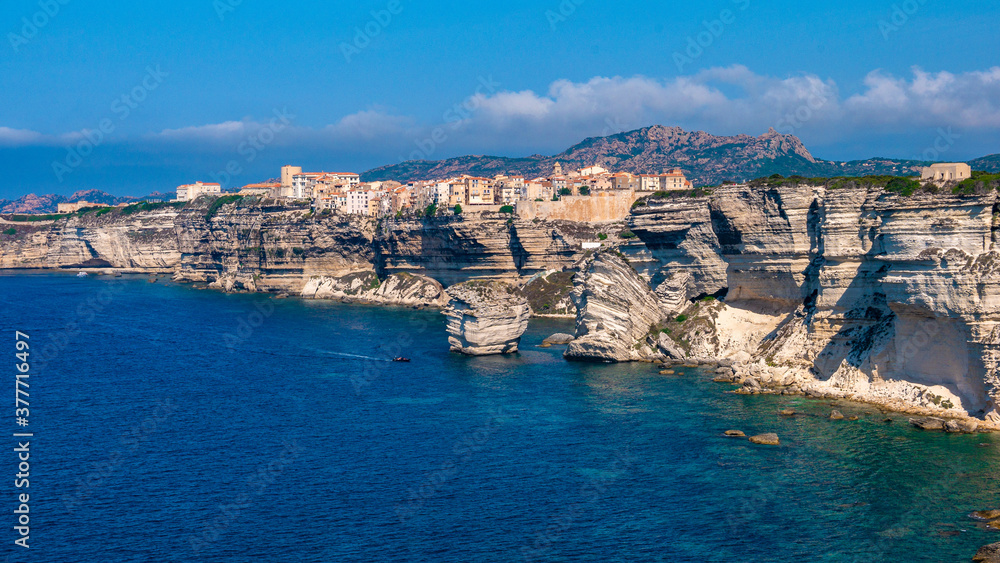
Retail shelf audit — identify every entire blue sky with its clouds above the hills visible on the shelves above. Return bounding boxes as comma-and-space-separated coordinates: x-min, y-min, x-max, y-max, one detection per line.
0, 0, 1000, 198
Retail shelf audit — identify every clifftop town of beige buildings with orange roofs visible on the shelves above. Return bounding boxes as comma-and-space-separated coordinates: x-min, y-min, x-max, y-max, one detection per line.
177, 163, 692, 217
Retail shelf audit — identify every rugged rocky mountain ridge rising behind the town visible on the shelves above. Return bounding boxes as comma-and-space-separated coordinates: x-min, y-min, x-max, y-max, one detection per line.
362, 125, 1000, 185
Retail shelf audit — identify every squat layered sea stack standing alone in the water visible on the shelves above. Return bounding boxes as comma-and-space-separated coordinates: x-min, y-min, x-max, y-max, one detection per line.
444, 280, 531, 356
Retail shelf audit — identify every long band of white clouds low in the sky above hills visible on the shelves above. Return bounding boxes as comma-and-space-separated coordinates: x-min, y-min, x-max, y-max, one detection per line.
0, 65, 1000, 162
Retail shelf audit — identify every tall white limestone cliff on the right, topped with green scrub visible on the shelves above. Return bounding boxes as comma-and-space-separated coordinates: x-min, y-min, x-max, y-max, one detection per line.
632, 187, 1000, 423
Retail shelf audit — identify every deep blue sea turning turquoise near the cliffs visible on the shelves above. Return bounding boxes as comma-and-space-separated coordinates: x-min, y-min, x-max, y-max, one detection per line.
0, 274, 1000, 563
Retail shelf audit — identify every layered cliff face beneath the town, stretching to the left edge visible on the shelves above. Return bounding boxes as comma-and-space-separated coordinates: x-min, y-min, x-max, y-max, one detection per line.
0, 201, 596, 302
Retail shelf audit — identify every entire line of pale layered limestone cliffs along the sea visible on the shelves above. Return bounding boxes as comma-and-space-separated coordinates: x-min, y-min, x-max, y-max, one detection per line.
0, 185, 1000, 430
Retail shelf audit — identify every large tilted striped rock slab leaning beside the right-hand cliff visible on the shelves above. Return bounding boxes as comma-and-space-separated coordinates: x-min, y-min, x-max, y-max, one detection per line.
565, 252, 661, 362
